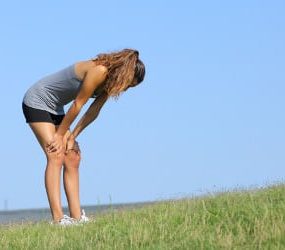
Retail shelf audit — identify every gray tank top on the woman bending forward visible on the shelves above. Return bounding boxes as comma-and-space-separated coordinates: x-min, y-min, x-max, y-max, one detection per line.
23, 63, 82, 115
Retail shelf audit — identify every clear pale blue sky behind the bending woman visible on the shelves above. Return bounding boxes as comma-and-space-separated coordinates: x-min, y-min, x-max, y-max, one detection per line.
0, 0, 285, 209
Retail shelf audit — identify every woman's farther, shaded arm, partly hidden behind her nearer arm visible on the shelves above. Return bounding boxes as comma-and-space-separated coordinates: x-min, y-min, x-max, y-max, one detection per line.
71, 92, 108, 138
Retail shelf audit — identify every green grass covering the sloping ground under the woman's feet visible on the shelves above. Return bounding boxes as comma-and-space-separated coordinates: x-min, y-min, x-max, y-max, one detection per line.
0, 183, 285, 250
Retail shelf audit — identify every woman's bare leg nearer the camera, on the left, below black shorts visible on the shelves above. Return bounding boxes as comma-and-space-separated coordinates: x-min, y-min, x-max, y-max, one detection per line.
29, 122, 64, 221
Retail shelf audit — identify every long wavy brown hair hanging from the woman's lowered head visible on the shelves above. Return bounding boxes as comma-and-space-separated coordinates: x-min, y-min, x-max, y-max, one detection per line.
91, 49, 145, 99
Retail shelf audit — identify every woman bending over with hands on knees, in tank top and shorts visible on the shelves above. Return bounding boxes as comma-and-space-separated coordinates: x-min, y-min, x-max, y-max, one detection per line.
22, 49, 145, 225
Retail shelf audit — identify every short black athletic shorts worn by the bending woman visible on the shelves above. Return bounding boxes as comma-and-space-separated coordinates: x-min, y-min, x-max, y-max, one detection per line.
22, 103, 65, 125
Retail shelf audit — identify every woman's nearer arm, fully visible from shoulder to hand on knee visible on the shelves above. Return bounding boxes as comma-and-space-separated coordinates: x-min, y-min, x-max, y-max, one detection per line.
47, 65, 107, 152
